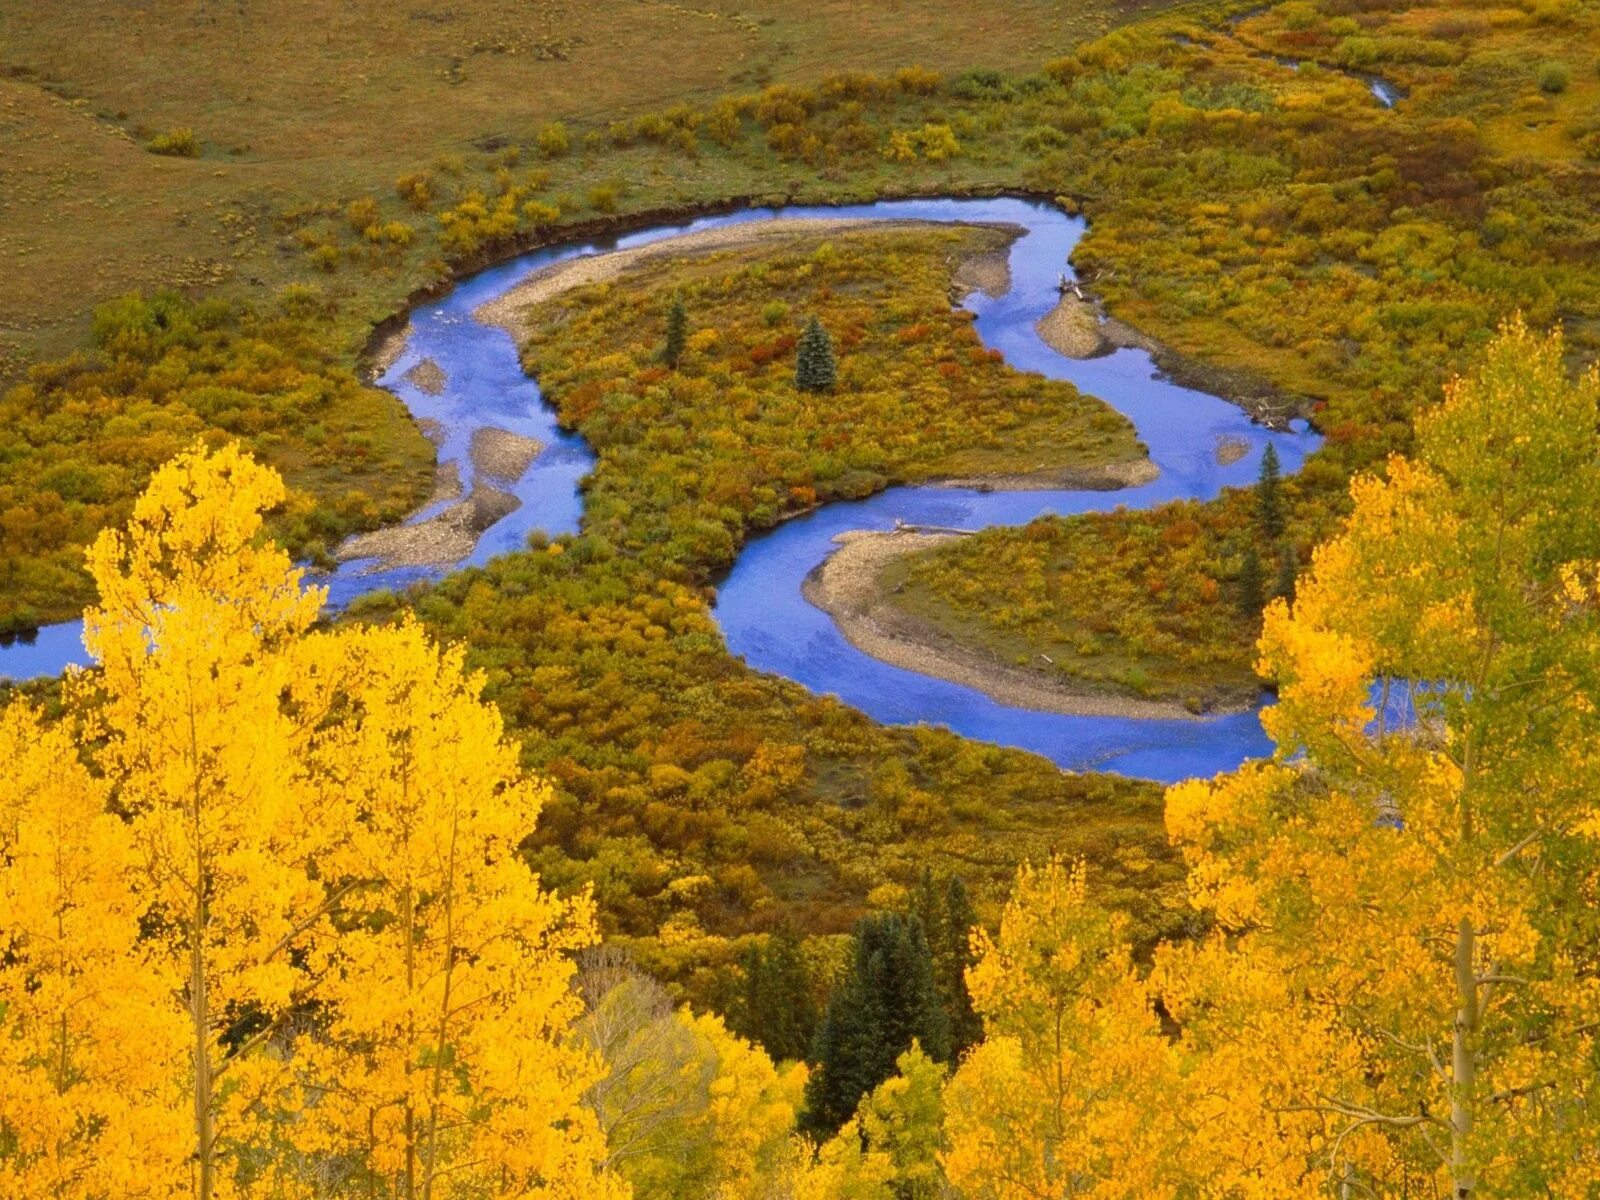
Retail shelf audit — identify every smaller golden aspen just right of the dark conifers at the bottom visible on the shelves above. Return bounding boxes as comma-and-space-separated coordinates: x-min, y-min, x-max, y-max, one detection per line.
944, 859, 1181, 1200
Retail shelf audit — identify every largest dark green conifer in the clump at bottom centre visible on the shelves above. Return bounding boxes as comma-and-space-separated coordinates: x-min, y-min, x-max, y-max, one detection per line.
805, 912, 950, 1134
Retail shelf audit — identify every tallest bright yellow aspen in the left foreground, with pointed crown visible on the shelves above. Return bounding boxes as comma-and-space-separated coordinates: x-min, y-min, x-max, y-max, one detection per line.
75, 446, 344, 1200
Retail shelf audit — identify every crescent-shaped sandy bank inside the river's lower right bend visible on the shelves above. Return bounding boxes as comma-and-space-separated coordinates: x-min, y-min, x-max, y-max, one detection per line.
802, 530, 1234, 720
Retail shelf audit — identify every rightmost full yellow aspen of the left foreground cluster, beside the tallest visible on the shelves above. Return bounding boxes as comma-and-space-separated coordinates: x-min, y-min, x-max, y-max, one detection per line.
290, 621, 626, 1197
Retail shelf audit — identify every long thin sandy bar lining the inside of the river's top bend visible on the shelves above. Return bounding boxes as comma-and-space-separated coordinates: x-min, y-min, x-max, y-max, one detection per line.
472, 216, 1024, 333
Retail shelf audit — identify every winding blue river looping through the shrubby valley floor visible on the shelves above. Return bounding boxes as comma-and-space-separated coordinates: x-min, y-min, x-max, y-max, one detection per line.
0, 197, 1318, 781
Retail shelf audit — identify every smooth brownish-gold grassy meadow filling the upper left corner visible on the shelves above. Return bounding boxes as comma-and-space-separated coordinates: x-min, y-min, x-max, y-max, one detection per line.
0, 0, 1162, 371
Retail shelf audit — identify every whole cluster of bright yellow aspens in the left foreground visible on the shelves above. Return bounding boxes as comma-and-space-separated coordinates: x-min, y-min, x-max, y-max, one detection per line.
0, 446, 629, 1200
